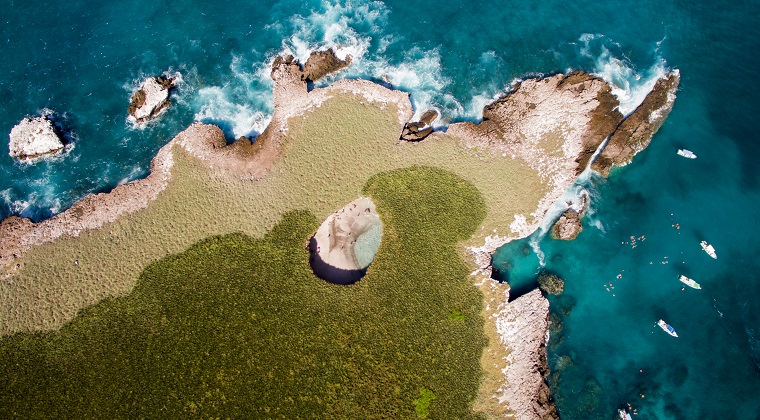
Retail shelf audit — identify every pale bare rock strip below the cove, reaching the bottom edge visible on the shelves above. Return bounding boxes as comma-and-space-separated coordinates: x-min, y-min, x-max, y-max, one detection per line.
496, 289, 559, 420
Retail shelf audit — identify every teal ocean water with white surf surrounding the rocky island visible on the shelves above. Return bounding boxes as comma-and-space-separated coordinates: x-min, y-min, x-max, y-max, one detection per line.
0, 0, 760, 419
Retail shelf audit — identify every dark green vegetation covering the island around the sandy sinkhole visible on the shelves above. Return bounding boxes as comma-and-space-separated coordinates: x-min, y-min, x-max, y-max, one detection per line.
0, 167, 485, 419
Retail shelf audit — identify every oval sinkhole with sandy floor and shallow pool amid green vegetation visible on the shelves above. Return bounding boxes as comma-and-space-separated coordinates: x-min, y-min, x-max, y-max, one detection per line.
309, 197, 383, 284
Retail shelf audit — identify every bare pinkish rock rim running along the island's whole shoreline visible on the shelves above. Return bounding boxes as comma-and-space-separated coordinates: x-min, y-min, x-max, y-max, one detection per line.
0, 48, 679, 419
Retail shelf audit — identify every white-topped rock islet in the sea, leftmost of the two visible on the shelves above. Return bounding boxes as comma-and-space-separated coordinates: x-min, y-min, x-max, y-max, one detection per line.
8, 116, 65, 160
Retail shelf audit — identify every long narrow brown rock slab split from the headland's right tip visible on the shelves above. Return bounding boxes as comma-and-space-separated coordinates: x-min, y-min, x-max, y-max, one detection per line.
591, 70, 680, 176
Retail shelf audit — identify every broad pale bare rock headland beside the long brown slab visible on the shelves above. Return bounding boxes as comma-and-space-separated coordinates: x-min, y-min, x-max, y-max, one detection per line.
447, 72, 623, 240
